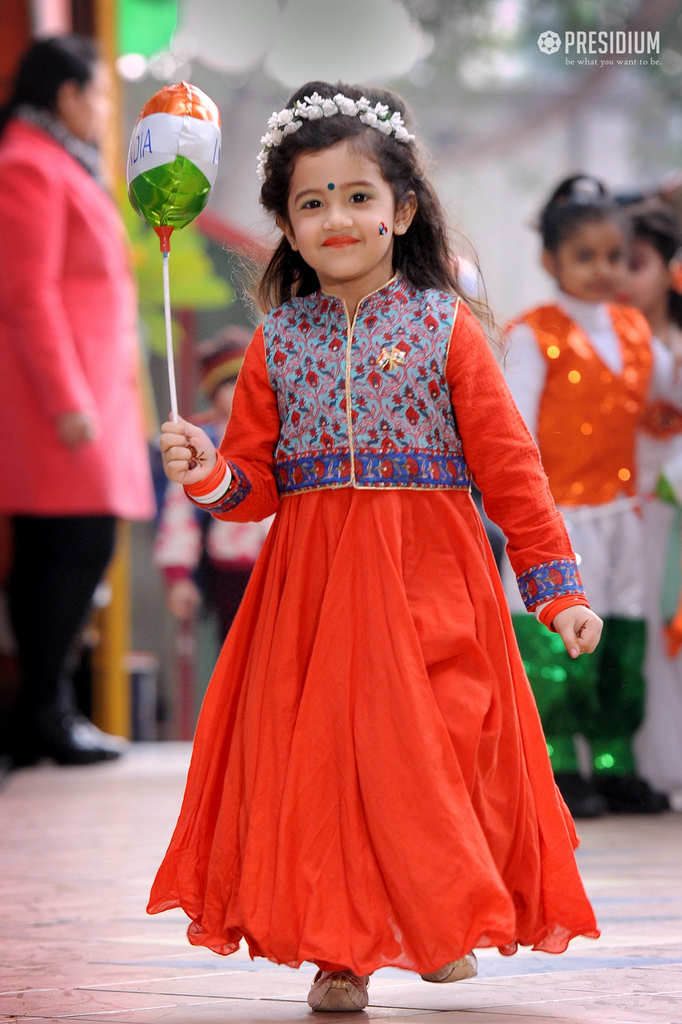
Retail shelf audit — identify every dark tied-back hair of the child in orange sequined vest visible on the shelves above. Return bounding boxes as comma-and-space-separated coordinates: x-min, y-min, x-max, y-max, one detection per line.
538, 174, 622, 253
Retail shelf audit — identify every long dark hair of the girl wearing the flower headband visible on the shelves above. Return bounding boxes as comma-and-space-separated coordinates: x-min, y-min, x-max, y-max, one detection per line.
256, 82, 483, 323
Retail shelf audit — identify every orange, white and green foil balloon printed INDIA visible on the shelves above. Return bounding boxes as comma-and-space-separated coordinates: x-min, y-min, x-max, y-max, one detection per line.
126, 82, 220, 227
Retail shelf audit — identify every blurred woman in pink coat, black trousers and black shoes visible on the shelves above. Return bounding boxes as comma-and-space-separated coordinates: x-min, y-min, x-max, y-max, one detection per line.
0, 36, 153, 764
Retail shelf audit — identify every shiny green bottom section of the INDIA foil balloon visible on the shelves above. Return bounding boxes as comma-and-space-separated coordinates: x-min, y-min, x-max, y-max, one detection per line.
128, 157, 211, 227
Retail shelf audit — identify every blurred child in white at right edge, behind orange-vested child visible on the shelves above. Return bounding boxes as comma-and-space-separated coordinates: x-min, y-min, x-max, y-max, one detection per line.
622, 198, 682, 806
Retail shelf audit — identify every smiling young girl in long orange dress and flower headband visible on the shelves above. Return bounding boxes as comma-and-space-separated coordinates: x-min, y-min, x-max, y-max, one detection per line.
148, 82, 601, 1011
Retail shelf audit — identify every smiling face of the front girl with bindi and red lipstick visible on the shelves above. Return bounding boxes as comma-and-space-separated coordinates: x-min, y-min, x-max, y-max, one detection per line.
279, 141, 417, 291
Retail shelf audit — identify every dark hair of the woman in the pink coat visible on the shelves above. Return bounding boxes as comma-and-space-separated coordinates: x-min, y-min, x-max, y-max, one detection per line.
0, 36, 99, 135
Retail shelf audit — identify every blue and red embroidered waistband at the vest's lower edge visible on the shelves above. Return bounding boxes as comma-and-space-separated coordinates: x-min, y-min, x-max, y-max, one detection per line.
275, 451, 471, 495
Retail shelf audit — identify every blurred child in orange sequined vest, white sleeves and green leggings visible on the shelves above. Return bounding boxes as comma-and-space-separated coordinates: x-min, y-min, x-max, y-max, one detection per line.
507, 175, 682, 817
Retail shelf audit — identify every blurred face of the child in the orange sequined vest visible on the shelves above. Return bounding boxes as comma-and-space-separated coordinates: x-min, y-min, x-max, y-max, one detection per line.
543, 220, 626, 302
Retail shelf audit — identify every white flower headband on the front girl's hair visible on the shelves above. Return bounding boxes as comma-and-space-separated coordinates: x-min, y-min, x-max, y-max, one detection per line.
257, 92, 415, 181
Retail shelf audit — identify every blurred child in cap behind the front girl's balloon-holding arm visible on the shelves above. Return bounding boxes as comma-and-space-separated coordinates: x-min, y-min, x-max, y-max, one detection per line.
155, 327, 272, 643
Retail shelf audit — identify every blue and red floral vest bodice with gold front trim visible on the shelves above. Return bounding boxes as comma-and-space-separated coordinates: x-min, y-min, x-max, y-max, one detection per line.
263, 274, 471, 495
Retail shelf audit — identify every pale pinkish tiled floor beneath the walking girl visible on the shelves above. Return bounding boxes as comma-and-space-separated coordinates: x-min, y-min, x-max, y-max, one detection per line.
0, 743, 682, 1024
